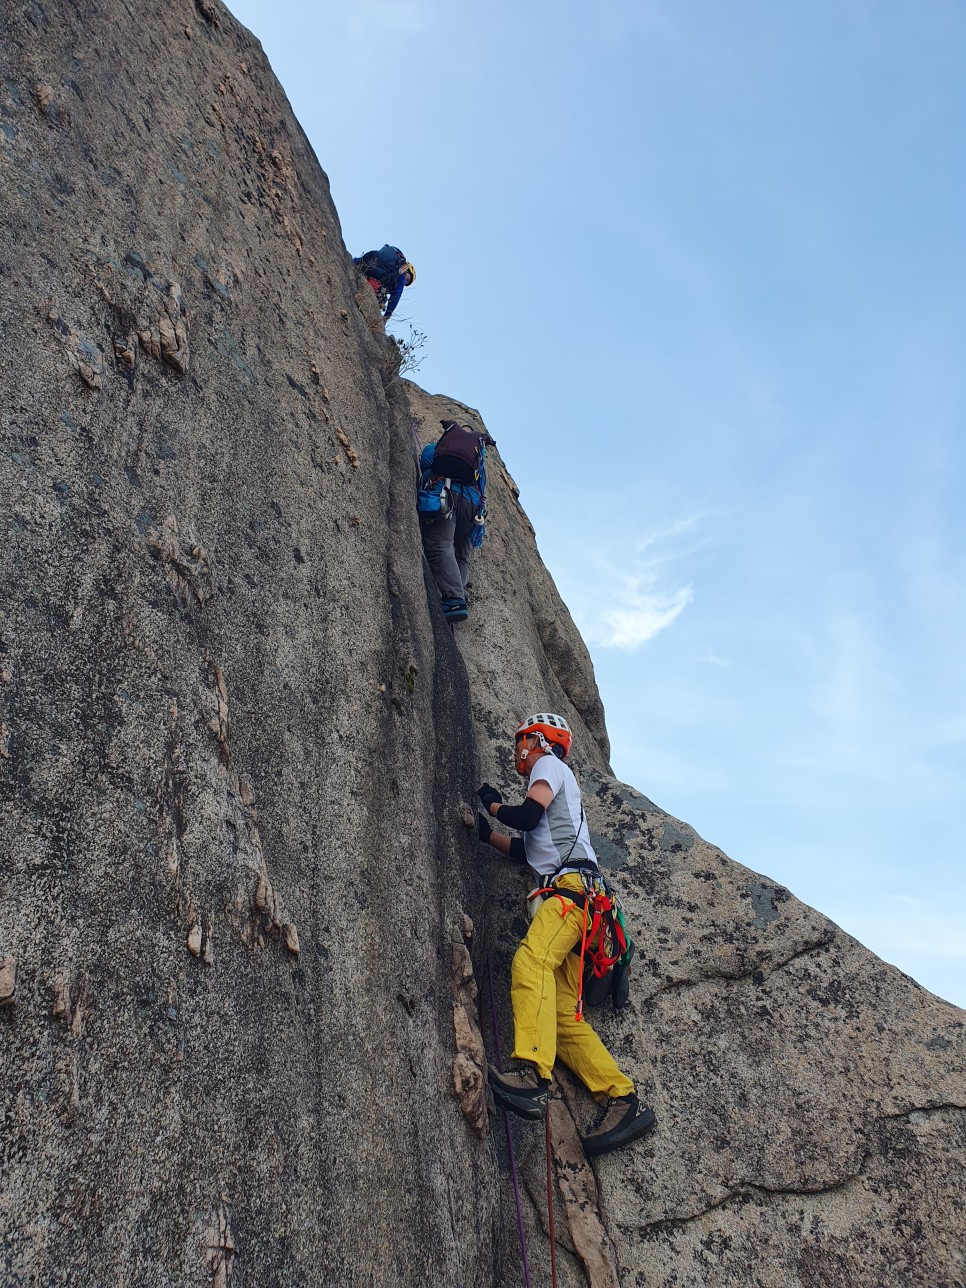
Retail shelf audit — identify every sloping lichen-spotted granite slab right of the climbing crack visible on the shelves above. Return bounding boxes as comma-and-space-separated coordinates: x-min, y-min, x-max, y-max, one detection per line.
407, 386, 966, 1288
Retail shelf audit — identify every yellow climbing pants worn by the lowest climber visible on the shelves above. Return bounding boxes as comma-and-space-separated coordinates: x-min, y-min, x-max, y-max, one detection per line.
510, 873, 634, 1100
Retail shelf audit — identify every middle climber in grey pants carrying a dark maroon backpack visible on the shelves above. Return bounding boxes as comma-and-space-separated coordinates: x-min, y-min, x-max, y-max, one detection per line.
417, 420, 493, 622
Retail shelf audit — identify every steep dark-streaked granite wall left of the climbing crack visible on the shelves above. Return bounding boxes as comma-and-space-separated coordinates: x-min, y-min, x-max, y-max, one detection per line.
0, 0, 500, 1288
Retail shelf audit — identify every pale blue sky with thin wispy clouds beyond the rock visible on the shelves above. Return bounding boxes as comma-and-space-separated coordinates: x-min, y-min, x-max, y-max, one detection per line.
233, 0, 966, 1005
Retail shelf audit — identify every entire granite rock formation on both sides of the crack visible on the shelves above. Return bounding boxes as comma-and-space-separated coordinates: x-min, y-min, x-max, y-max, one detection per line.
0, 0, 966, 1288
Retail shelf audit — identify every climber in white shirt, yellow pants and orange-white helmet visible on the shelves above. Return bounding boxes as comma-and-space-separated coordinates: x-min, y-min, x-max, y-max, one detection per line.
478, 712, 656, 1155
